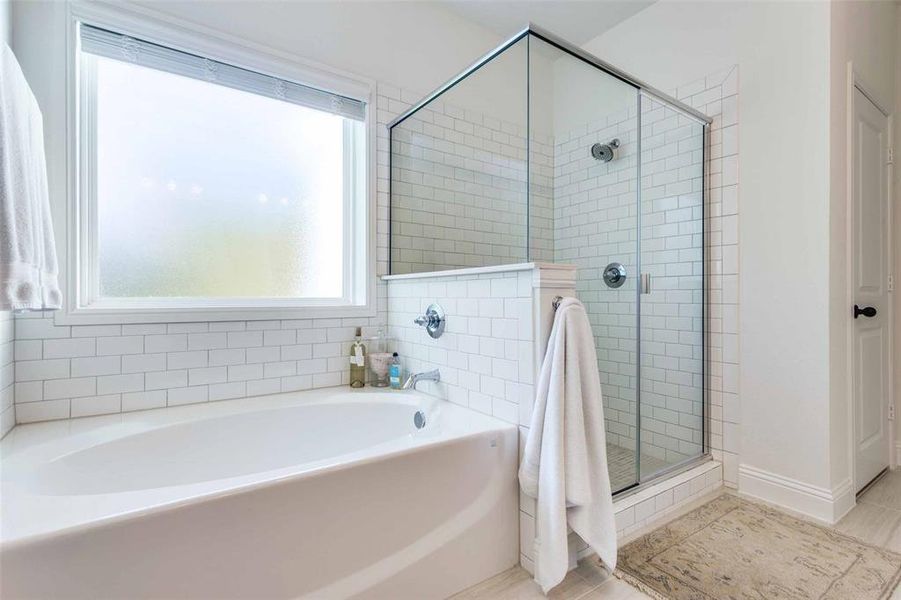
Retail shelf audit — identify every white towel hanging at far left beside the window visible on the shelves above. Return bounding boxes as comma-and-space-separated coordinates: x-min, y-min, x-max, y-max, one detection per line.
0, 44, 61, 310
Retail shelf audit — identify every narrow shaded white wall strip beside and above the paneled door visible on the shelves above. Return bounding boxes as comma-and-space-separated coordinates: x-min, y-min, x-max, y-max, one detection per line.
829, 1, 901, 506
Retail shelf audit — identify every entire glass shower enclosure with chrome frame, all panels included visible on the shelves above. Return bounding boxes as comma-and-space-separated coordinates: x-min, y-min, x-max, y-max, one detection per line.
389, 26, 710, 492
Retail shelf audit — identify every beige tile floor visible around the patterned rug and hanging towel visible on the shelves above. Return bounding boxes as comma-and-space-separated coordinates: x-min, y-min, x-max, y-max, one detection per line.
453, 470, 901, 600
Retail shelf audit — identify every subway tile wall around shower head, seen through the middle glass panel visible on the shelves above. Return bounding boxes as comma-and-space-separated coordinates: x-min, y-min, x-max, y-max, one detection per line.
553, 102, 638, 464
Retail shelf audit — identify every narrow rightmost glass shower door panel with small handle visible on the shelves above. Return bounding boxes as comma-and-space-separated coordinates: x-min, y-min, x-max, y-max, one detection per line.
638, 93, 704, 481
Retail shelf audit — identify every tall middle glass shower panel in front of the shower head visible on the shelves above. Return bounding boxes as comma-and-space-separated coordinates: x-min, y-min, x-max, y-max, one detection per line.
528, 36, 641, 492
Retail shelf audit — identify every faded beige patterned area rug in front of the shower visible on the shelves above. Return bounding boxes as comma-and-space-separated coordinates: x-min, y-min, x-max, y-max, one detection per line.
617, 495, 901, 600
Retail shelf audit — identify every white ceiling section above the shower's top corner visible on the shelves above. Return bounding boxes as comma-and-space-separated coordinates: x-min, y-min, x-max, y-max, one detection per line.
438, 0, 655, 46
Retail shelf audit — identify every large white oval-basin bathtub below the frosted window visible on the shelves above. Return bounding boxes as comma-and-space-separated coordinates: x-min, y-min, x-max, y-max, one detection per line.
0, 388, 519, 599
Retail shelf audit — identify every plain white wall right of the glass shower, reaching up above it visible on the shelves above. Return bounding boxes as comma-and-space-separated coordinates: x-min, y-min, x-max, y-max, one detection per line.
585, 1, 831, 516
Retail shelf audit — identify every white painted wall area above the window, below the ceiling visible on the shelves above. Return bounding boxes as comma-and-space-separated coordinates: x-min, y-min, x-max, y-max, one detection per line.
134, 0, 501, 93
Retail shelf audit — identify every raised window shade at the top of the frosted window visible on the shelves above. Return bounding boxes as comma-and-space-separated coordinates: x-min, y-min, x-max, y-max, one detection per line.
81, 23, 366, 121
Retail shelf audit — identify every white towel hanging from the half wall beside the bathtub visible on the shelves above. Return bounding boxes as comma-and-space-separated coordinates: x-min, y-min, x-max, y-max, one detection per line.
519, 298, 616, 593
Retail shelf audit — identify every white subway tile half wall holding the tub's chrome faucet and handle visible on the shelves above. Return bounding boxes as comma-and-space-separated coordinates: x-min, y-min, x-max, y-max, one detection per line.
388, 270, 535, 424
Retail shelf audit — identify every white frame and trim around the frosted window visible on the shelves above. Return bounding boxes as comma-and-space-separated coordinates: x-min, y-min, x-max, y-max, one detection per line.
56, 2, 376, 324
